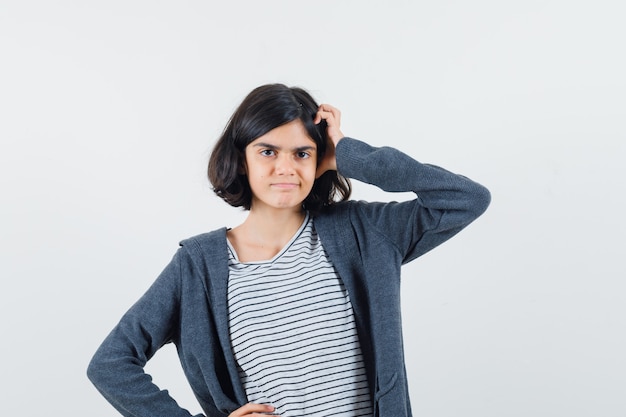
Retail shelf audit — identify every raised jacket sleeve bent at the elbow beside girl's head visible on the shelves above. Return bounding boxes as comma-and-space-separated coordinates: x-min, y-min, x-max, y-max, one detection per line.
336, 138, 491, 263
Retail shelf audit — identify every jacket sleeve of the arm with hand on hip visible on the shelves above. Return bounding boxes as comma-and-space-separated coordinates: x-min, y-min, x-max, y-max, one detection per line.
87, 249, 202, 417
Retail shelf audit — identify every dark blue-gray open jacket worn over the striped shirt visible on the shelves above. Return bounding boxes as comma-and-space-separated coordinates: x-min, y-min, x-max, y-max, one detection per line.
87, 138, 490, 417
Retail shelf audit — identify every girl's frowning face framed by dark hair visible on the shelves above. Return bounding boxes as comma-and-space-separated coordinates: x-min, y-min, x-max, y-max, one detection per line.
245, 120, 317, 211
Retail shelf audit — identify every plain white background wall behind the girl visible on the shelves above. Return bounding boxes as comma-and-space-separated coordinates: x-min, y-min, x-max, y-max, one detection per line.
0, 0, 626, 417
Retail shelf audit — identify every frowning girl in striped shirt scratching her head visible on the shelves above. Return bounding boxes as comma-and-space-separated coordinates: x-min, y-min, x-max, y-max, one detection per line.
88, 84, 490, 417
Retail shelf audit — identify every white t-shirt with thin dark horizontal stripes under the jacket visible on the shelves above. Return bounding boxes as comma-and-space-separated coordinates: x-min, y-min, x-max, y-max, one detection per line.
228, 214, 372, 417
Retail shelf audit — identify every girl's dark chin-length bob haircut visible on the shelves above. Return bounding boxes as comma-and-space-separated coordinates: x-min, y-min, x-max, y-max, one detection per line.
208, 84, 352, 213
